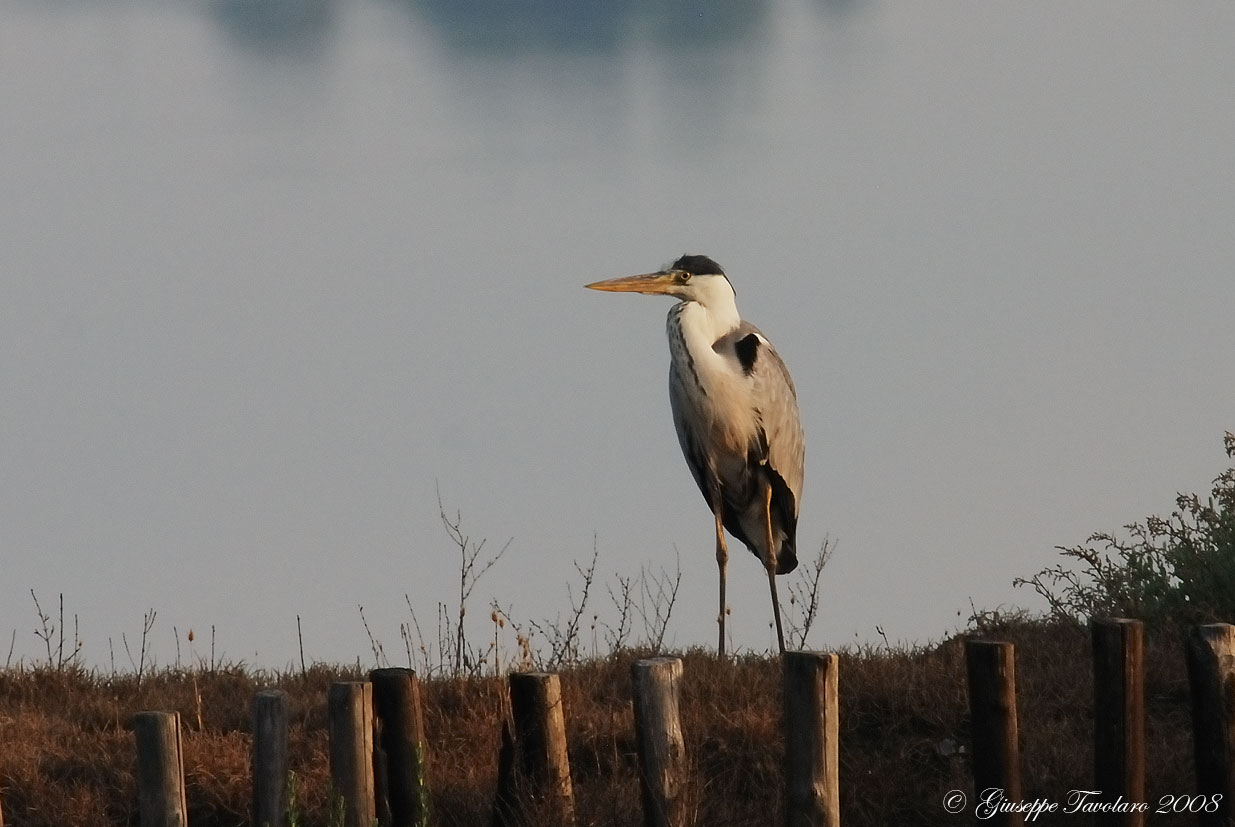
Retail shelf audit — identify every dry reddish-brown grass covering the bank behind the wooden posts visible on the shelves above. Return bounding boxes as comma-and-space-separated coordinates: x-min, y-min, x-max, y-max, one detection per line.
0, 622, 1194, 827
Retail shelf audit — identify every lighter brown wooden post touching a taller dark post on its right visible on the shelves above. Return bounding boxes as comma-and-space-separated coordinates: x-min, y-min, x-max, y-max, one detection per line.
329, 681, 377, 827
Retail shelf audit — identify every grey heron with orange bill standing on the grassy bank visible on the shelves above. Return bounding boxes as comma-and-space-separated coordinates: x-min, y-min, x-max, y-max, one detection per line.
587, 256, 805, 654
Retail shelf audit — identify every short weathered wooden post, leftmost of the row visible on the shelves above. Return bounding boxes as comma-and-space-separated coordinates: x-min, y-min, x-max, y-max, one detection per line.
133, 712, 189, 827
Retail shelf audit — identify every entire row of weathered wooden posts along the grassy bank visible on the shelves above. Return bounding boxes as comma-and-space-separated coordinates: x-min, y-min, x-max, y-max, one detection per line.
9, 620, 1235, 827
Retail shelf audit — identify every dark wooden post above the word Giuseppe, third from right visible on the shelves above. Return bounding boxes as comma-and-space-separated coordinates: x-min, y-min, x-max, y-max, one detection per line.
965, 639, 1025, 825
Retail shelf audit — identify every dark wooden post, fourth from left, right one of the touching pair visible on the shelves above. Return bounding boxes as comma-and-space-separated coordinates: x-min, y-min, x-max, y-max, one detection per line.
369, 669, 429, 827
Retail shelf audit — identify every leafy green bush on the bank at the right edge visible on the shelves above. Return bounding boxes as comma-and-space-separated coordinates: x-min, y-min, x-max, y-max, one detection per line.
1014, 431, 1235, 623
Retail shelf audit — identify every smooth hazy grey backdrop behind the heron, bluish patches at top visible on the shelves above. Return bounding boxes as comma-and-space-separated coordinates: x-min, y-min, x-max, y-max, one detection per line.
0, 0, 1235, 667
